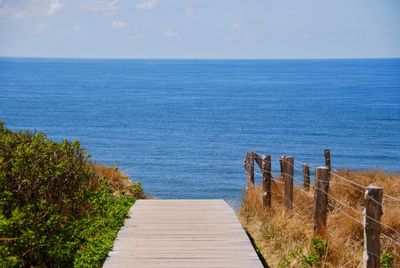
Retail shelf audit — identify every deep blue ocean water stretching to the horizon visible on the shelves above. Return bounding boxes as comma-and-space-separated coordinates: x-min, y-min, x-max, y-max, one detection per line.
0, 58, 400, 205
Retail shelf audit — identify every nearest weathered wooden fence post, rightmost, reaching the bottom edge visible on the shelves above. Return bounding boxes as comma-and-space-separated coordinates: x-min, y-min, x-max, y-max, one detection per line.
364, 185, 383, 268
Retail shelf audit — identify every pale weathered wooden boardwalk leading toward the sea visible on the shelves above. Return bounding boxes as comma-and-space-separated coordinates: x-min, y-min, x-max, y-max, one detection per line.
104, 200, 263, 268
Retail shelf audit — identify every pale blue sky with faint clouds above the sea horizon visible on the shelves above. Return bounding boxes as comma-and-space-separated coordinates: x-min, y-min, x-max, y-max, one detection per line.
0, 0, 400, 59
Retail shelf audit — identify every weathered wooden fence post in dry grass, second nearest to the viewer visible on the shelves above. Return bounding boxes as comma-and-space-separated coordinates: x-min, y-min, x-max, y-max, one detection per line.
314, 167, 329, 238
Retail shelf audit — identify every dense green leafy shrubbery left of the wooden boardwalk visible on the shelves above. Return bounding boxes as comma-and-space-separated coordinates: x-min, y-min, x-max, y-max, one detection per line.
0, 122, 143, 267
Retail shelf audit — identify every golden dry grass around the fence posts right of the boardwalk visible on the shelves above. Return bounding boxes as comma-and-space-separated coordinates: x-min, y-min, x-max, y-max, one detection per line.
239, 171, 400, 267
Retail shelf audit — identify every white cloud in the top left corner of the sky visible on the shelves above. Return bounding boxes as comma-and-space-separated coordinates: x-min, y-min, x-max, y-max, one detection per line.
0, 0, 65, 19
